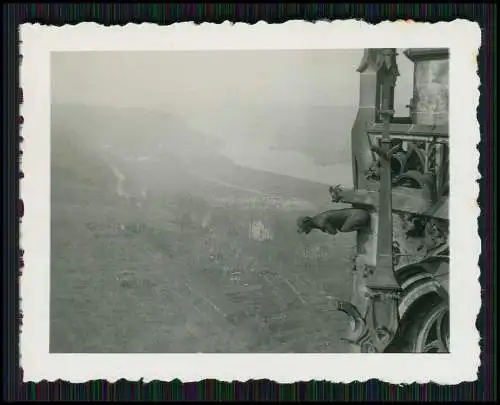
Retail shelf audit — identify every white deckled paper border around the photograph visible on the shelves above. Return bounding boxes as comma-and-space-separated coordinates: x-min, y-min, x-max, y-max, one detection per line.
20, 20, 481, 384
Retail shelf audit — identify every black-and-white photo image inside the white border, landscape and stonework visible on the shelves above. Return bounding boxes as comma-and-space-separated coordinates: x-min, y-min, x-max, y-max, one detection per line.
49, 48, 450, 353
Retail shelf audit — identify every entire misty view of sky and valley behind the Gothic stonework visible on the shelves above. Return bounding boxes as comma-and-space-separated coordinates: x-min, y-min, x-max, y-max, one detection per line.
50, 50, 413, 353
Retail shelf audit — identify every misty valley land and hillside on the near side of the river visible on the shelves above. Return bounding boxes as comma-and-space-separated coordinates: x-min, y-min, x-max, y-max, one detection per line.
50, 107, 354, 353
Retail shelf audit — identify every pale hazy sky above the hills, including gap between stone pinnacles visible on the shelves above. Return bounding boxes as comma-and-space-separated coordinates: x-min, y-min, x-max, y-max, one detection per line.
52, 50, 413, 110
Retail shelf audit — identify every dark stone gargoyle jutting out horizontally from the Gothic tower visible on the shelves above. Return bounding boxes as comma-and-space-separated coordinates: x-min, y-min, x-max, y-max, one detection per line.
297, 208, 370, 235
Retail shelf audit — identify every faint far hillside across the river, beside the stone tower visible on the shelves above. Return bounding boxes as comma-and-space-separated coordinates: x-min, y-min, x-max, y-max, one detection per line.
179, 104, 358, 166
